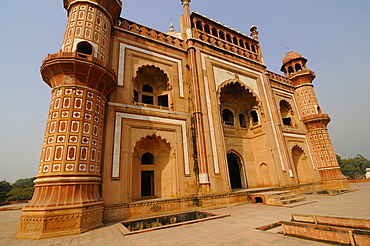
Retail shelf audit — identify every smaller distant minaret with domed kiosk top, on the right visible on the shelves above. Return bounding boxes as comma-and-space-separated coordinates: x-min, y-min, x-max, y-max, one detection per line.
281, 51, 347, 188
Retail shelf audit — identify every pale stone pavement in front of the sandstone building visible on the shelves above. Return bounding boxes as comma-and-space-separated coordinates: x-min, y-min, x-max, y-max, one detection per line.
0, 183, 370, 246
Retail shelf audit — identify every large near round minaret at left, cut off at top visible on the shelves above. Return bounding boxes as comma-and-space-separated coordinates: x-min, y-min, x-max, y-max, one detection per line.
17, 0, 122, 239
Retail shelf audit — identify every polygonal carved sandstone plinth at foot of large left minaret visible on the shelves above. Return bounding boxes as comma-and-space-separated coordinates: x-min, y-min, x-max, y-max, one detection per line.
15, 204, 103, 239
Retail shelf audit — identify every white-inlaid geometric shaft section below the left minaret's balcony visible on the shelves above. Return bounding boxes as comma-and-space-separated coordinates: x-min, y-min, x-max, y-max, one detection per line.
39, 86, 105, 175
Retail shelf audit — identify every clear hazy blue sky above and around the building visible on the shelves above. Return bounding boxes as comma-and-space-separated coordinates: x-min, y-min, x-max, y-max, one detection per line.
0, 0, 370, 182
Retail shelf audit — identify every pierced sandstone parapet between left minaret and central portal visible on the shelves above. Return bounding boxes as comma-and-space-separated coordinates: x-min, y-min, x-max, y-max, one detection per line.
115, 18, 185, 49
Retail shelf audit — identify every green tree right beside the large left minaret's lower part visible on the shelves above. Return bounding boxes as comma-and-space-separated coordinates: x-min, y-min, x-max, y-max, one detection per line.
6, 178, 36, 201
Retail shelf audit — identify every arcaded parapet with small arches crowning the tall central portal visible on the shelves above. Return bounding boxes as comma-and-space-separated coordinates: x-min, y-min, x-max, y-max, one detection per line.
191, 12, 262, 63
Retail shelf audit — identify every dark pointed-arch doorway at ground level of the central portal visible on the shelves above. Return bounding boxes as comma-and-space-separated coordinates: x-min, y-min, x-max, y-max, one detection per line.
226, 152, 246, 189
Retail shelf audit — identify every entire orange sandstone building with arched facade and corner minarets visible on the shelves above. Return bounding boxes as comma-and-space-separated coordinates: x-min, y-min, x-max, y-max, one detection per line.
18, 0, 346, 238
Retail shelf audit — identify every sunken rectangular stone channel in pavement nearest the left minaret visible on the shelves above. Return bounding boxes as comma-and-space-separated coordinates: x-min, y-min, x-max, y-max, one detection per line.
122, 211, 230, 235
